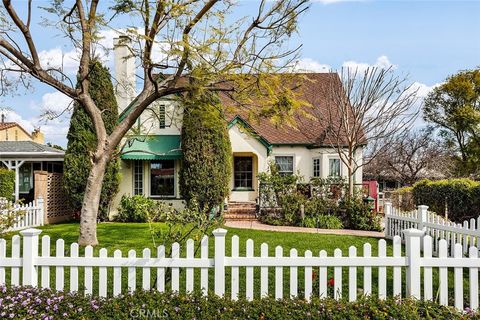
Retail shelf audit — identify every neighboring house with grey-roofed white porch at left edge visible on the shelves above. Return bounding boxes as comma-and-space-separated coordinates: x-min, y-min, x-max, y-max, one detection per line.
0, 117, 65, 202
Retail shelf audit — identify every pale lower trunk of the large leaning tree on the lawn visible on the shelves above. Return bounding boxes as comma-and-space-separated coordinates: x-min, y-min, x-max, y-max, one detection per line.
78, 153, 108, 246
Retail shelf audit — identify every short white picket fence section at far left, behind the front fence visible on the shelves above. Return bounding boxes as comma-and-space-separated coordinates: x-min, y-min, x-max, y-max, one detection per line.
0, 197, 44, 231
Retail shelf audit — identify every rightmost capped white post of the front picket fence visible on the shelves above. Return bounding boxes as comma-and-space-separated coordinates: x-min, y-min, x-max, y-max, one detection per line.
403, 229, 425, 299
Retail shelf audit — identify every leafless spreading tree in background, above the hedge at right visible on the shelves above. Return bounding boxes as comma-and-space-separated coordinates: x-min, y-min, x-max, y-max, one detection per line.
365, 130, 453, 185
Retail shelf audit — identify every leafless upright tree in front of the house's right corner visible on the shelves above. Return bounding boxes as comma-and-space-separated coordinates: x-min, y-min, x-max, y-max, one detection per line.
320, 67, 419, 195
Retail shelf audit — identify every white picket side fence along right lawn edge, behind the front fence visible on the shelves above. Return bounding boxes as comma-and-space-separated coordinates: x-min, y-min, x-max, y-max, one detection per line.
385, 203, 480, 256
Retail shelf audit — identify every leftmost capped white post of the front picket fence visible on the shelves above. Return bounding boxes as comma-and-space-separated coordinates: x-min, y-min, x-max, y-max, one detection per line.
20, 228, 42, 287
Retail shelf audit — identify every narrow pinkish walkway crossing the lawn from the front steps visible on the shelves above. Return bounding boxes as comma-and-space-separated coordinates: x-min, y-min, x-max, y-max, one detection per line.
225, 221, 385, 238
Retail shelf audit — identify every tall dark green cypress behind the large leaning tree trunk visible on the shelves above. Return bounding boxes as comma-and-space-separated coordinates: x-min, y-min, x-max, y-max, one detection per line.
63, 61, 120, 220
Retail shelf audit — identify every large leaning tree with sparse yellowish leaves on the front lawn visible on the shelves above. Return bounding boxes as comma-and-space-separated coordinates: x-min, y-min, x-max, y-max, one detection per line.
0, 0, 308, 245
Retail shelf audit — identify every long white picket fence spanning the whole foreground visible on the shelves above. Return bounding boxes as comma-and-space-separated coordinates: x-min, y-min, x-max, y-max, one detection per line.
0, 229, 480, 310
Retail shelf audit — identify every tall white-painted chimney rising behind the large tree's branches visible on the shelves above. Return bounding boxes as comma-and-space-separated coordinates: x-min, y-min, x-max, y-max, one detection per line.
113, 36, 136, 112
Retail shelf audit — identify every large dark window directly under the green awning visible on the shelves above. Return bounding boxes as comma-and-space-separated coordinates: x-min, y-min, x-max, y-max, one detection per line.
150, 160, 175, 197
